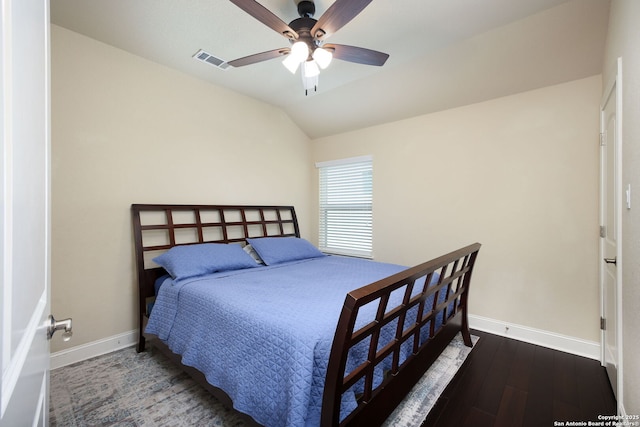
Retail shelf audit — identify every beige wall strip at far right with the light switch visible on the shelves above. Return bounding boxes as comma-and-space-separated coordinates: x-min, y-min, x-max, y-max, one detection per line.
603, 0, 640, 415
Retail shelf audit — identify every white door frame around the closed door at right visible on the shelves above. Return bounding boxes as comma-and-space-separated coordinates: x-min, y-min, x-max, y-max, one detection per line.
599, 58, 624, 411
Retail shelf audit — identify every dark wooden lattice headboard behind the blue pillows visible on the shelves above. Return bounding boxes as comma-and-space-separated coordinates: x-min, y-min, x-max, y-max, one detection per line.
131, 204, 300, 352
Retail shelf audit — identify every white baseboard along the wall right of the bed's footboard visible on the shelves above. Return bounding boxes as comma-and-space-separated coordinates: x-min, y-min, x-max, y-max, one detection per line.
469, 314, 600, 360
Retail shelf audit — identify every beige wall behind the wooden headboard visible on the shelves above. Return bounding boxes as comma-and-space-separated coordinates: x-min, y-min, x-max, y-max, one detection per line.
51, 26, 311, 352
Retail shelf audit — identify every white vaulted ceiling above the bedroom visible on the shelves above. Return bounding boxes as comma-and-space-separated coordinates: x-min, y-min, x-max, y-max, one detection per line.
51, 0, 609, 139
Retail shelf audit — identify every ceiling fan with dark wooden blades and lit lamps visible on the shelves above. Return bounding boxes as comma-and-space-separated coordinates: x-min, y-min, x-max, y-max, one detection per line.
228, 0, 389, 93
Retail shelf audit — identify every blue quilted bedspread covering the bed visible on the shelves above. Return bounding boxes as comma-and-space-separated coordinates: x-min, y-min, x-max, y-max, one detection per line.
146, 256, 430, 427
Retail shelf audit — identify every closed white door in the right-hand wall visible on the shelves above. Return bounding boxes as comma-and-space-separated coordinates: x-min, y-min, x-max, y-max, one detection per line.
600, 61, 622, 401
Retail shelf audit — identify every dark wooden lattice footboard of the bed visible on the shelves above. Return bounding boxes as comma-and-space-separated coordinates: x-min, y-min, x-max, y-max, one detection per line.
321, 243, 480, 427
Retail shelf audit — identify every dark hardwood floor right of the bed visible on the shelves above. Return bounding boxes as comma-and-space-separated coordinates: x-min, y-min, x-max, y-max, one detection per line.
422, 331, 616, 427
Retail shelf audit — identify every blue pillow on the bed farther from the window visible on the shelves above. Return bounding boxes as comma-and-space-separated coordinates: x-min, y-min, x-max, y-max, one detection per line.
153, 243, 257, 280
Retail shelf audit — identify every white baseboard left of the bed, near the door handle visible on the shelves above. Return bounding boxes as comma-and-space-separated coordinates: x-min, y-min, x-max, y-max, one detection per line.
50, 330, 138, 369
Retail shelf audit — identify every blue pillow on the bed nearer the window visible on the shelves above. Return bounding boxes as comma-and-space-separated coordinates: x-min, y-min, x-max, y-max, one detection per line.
247, 237, 326, 265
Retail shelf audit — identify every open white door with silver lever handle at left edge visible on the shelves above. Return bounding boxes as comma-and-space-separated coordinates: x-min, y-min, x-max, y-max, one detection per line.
0, 0, 50, 427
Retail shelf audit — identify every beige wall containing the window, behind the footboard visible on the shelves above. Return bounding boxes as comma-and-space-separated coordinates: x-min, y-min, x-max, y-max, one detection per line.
312, 76, 601, 341
